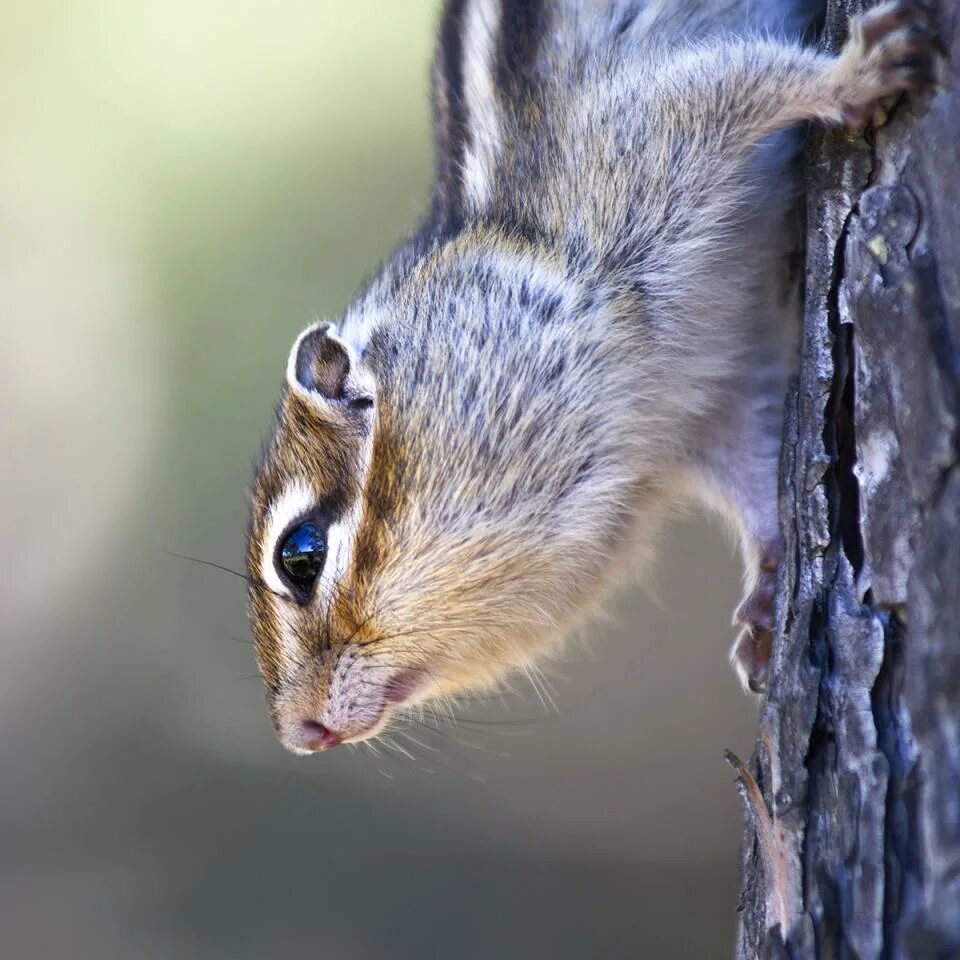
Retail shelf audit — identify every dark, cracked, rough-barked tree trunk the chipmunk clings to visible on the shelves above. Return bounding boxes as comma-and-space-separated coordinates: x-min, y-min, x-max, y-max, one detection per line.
737, 0, 960, 958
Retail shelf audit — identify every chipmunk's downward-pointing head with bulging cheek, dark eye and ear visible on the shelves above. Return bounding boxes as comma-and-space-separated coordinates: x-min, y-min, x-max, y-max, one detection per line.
248, 240, 640, 752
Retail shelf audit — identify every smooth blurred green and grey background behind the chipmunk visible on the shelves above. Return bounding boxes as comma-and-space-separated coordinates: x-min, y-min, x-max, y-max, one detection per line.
0, 0, 755, 960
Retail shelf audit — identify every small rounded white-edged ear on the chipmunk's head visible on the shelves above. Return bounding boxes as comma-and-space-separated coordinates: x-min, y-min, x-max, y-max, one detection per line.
287, 322, 374, 408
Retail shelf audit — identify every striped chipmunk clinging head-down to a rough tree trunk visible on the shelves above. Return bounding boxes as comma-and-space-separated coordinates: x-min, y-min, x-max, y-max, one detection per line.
247, 0, 932, 753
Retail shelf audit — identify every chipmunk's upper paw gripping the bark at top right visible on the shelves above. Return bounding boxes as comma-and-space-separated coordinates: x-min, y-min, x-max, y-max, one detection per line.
836, 0, 937, 127
